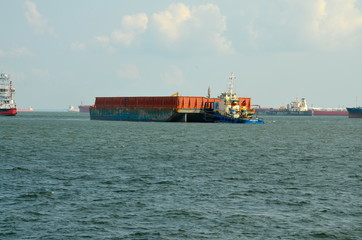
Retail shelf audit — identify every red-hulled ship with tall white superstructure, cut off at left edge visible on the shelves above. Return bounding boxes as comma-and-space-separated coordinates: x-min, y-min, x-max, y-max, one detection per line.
0, 73, 17, 116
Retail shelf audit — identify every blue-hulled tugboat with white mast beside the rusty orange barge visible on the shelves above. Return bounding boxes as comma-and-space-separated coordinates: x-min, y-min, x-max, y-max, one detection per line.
205, 73, 264, 124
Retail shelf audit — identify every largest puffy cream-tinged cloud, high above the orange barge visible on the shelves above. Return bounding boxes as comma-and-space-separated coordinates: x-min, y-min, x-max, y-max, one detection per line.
153, 3, 234, 54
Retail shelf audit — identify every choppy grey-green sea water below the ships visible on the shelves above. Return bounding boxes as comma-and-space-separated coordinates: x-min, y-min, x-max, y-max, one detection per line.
0, 112, 362, 240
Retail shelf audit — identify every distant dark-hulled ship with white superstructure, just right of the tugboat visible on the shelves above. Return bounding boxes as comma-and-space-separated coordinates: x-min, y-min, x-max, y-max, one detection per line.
255, 98, 313, 116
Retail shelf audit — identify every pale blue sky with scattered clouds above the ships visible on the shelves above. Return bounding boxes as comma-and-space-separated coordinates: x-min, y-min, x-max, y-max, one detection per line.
0, 0, 362, 110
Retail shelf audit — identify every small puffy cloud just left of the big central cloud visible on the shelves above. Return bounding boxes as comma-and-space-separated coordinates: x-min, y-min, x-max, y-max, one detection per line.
111, 13, 148, 46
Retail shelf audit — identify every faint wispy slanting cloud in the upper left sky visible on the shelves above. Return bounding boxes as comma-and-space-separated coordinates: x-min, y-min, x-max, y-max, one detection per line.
24, 0, 55, 36
